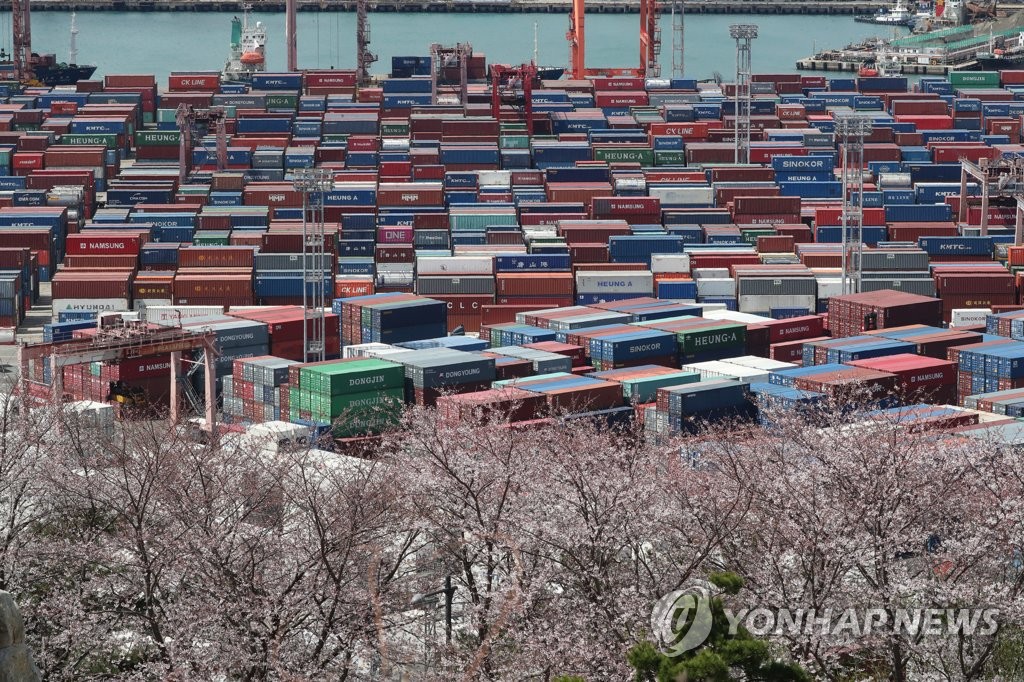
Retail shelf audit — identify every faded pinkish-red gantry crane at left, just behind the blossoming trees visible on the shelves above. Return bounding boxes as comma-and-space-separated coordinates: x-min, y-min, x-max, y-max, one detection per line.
17, 316, 219, 432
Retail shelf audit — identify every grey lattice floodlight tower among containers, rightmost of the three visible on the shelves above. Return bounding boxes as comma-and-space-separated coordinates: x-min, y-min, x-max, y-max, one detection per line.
836, 114, 871, 294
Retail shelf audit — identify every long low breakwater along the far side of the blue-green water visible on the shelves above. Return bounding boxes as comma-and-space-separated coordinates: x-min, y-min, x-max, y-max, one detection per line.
0, 0, 892, 14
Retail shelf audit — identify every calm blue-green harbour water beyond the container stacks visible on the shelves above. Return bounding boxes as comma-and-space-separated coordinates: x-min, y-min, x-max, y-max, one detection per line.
0, 11, 909, 84
